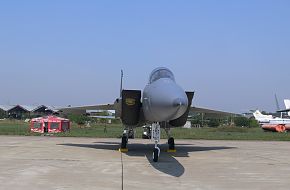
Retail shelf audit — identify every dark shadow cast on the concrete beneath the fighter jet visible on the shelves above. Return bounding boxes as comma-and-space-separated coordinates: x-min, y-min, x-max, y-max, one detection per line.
59, 142, 235, 177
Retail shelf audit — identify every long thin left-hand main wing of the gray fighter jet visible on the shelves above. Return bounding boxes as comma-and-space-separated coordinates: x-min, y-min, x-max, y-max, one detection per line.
58, 104, 115, 114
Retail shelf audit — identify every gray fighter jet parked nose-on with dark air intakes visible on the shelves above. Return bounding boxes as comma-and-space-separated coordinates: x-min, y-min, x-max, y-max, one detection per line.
61, 67, 232, 162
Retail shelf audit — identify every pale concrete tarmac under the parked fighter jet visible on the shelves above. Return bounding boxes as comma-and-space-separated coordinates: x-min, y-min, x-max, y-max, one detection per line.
0, 136, 290, 190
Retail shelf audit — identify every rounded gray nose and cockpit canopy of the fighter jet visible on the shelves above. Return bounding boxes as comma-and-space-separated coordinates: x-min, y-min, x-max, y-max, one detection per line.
142, 67, 188, 122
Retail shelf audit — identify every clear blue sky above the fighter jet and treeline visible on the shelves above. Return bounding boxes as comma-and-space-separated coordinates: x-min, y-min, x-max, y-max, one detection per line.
0, 0, 290, 112
